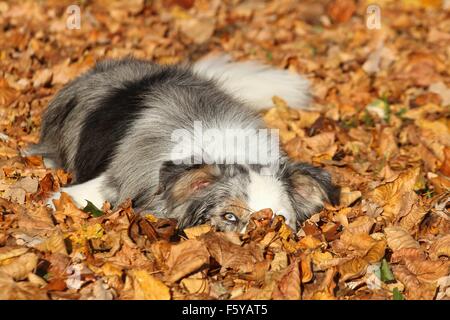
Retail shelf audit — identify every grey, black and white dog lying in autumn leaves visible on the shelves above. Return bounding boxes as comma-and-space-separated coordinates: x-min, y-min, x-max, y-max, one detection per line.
25, 55, 340, 232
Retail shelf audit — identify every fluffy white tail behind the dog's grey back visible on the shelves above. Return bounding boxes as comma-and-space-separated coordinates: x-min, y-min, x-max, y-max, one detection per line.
193, 54, 310, 110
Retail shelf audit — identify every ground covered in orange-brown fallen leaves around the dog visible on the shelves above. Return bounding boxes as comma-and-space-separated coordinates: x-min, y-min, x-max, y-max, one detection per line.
0, 0, 450, 299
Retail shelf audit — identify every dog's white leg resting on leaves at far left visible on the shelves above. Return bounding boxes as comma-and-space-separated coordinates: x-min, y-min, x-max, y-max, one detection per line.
47, 176, 106, 209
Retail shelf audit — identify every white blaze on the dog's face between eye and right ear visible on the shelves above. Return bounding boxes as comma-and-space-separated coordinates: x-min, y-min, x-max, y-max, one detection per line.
247, 171, 297, 230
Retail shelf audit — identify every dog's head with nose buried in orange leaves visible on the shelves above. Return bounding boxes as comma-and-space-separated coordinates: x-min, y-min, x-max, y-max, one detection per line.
158, 160, 340, 232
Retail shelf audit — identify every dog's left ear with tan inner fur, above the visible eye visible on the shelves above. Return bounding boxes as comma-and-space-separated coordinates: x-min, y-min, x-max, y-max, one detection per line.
157, 161, 219, 204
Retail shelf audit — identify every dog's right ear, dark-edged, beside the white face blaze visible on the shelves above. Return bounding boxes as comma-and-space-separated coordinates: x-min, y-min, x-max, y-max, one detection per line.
282, 162, 341, 220
